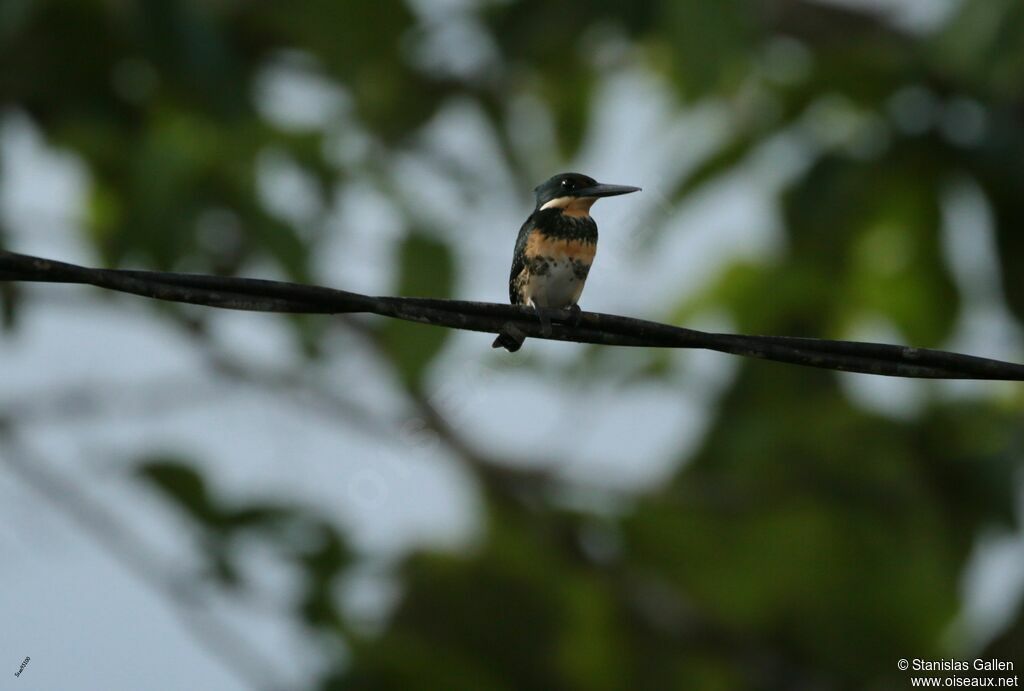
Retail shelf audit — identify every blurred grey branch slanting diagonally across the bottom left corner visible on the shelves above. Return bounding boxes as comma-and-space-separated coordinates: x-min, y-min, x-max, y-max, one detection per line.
0, 418, 287, 689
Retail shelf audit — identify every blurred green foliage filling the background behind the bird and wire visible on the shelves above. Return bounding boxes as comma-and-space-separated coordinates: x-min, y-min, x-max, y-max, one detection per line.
6, 0, 1024, 689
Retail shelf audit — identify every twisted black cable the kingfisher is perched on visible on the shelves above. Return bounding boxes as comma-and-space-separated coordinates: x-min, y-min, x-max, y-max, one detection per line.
0, 252, 1024, 381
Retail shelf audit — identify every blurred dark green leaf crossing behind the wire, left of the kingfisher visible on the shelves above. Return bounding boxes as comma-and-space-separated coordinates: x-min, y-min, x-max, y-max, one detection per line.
380, 233, 455, 391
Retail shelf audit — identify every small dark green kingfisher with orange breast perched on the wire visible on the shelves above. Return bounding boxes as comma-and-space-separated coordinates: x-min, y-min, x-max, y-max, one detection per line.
493, 173, 640, 352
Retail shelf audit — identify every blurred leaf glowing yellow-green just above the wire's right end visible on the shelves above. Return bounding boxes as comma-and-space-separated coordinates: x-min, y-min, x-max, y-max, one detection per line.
785, 148, 957, 346
